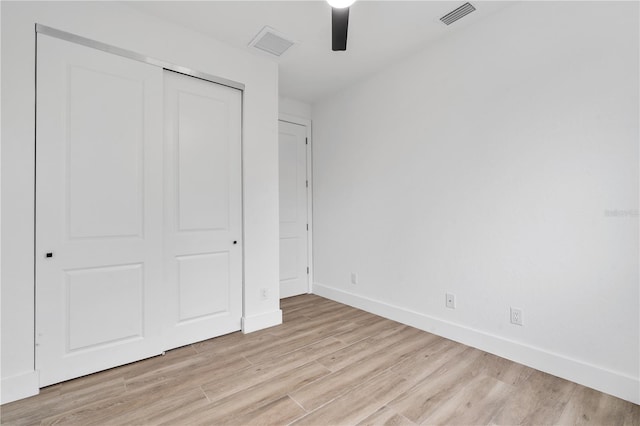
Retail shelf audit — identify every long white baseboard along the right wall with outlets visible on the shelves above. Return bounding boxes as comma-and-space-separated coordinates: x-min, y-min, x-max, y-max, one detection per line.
313, 282, 640, 404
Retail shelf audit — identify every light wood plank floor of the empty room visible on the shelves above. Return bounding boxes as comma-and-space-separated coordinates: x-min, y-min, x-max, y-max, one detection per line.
1, 295, 640, 425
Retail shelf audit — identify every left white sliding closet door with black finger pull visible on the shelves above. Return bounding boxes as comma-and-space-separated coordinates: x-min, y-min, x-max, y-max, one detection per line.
35, 35, 163, 386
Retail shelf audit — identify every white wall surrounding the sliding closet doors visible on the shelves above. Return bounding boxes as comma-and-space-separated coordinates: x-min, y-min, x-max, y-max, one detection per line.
1, 1, 282, 402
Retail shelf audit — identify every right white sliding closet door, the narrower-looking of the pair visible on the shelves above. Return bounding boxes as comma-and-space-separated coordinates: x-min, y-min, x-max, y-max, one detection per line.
164, 71, 242, 349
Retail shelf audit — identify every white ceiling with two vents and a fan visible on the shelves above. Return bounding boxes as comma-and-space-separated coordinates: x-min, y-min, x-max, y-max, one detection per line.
126, 0, 511, 103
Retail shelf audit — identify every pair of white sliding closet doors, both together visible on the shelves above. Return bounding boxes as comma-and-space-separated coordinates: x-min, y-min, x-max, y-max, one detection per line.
35, 30, 242, 387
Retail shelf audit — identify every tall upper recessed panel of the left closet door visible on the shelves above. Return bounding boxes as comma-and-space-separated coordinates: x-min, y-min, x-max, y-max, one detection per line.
66, 66, 145, 238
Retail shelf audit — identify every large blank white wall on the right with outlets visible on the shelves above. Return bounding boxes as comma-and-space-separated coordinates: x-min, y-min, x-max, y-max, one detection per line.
313, 2, 640, 403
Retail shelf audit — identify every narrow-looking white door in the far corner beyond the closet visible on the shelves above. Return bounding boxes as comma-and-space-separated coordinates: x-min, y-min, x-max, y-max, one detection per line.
278, 121, 309, 298
